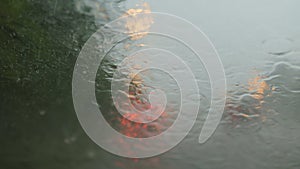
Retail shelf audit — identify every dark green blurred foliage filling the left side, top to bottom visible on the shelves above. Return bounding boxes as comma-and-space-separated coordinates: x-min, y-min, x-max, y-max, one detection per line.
0, 0, 105, 168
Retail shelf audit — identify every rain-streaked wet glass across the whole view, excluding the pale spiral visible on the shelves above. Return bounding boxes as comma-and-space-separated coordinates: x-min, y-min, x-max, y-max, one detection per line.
0, 0, 300, 169
